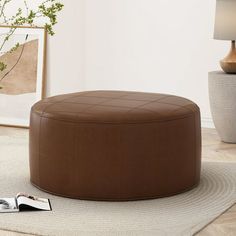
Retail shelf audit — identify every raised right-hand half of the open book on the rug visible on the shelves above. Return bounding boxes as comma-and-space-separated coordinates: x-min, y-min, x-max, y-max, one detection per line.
16, 193, 51, 211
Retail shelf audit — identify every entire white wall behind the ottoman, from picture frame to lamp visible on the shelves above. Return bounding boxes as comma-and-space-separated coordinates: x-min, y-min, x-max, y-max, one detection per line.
47, 0, 229, 127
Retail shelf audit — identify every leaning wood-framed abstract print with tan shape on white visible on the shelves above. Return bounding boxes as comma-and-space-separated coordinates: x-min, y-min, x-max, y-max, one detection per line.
0, 26, 47, 127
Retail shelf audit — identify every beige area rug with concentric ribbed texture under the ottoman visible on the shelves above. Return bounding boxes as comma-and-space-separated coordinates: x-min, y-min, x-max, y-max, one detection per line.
0, 137, 236, 236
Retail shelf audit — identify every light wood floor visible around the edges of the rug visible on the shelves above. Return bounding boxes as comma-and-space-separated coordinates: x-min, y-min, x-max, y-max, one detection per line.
0, 126, 236, 236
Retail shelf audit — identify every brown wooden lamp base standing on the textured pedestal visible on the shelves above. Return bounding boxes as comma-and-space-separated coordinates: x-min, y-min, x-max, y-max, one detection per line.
220, 41, 236, 74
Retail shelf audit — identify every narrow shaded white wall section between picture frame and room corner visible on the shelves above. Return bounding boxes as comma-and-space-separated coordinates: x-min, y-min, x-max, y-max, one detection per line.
46, 0, 86, 96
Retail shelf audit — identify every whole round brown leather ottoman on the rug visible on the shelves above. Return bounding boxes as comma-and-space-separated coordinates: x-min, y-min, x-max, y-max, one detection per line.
30, 91, 201, 201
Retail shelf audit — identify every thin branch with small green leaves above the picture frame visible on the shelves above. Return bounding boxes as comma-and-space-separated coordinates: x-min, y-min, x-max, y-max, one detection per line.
0, 0, 64, 71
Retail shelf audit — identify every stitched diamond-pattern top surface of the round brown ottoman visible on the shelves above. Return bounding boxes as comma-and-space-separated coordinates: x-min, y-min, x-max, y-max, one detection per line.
33, 91, 198, 123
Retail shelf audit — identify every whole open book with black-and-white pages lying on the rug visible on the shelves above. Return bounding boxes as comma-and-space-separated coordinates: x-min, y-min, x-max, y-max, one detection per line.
0, 193, 52, 213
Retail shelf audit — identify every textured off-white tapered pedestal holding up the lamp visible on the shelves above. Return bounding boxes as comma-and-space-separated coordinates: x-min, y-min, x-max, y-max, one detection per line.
208, 71, 236, 143
